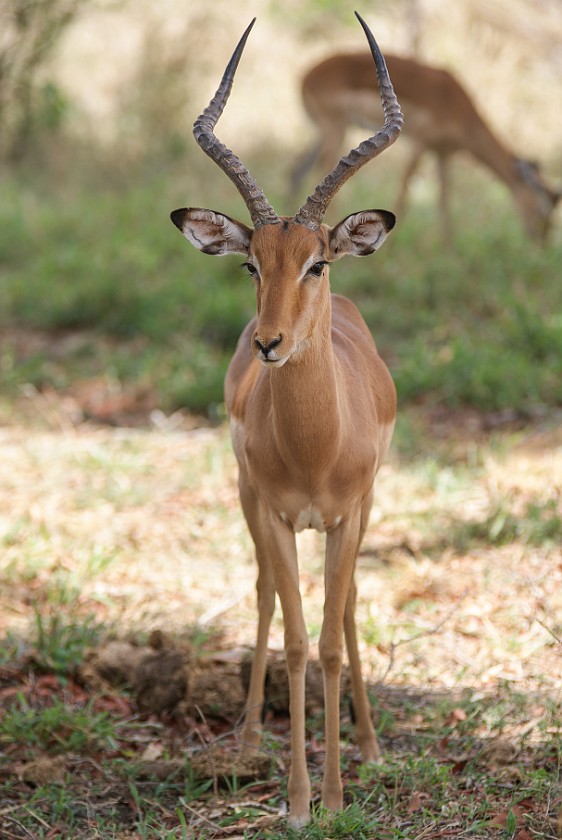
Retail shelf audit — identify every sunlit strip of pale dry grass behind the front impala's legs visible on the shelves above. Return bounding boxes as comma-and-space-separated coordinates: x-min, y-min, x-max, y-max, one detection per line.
0, 394, 562, 689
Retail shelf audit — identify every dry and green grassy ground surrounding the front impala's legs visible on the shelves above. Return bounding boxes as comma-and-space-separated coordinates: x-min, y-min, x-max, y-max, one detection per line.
0, 402, 562, 840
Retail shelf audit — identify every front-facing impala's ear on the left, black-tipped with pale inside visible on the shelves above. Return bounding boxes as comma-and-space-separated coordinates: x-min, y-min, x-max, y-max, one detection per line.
170, 207, 252, 256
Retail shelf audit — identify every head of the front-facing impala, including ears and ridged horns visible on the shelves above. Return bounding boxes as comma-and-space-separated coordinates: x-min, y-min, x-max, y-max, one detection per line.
171, 13, 403, 367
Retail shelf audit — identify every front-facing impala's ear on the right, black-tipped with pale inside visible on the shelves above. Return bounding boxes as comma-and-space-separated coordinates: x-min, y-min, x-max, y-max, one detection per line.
329, 210, 396, 260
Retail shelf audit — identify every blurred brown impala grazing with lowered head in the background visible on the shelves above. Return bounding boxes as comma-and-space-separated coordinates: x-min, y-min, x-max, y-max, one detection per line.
292, 53, 561, 240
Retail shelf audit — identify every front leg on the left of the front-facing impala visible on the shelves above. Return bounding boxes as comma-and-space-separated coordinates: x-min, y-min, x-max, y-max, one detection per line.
268, 516, 310, 828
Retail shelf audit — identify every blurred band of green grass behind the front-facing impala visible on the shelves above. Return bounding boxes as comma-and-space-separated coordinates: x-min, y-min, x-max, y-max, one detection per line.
0, 154, 562, 416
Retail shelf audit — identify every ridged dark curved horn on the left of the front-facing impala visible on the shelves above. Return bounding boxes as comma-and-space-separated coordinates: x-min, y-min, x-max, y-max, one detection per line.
193, 18, 279, 228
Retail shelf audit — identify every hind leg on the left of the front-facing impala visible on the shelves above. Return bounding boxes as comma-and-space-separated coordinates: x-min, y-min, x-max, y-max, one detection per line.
235, 477, 275, 753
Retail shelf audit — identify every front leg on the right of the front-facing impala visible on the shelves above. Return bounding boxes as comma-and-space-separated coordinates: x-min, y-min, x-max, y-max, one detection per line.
319, 509, 361, 811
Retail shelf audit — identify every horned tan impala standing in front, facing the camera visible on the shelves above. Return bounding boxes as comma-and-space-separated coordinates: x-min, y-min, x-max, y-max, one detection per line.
172, 15, 402, 827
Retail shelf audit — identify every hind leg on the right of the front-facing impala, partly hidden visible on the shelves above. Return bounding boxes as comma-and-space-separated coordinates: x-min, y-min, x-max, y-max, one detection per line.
343, 492, 380, 762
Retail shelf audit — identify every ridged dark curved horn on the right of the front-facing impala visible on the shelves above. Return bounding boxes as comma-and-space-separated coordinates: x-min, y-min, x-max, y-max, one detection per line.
295, 12, 404, 230
